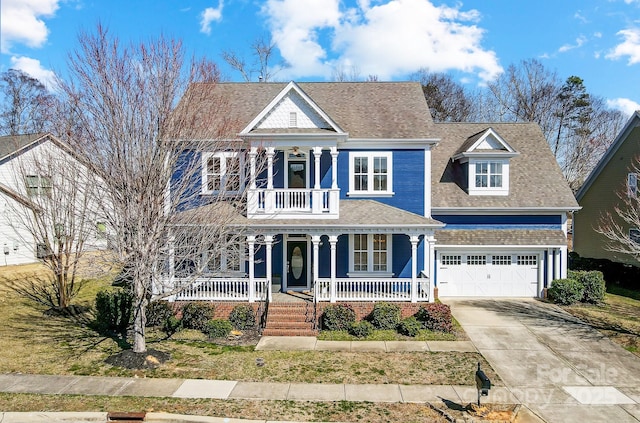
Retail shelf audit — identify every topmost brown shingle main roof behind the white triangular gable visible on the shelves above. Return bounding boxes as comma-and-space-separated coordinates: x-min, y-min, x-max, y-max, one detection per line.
177, 82, 433, 139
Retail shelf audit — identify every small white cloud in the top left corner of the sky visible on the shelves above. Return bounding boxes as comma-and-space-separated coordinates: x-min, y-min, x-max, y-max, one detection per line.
0, 0, 60, 53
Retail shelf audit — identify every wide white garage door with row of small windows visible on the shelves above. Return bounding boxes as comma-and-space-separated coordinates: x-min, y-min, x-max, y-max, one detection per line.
436, 252, 539, 297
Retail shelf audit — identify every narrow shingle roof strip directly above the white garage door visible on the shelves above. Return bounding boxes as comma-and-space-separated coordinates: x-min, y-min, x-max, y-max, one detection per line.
435, 229, 567, 246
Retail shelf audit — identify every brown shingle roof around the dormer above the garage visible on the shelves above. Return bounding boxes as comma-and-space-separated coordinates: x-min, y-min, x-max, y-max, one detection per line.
431, 123, 579, 210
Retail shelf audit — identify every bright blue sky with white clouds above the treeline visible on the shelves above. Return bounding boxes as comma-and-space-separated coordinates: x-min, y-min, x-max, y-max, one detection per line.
0, 0, 640, 115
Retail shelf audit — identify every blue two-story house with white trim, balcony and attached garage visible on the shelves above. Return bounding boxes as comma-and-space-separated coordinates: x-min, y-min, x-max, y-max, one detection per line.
162, 82, 578, 312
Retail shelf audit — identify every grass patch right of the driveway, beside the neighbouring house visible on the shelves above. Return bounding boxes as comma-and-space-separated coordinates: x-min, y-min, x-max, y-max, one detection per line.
565, 290, 640, 357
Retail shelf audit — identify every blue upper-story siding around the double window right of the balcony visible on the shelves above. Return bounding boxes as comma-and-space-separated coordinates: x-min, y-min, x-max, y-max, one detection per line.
338, 150, 425, 215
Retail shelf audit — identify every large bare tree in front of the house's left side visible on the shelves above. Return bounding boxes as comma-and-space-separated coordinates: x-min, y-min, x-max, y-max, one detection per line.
60, 26, 262, 352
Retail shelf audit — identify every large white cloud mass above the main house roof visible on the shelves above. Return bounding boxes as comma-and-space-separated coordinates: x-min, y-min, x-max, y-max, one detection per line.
263, 0, 502, 81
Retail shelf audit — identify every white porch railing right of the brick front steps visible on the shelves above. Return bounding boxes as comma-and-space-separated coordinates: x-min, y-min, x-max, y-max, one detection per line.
314, 278, 429, 302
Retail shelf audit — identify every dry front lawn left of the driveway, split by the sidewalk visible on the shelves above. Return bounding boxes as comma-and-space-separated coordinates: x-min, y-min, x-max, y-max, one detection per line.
0, 266, 501, 422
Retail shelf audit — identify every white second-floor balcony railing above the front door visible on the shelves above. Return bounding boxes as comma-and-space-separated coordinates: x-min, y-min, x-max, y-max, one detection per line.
247, 188, 340, 219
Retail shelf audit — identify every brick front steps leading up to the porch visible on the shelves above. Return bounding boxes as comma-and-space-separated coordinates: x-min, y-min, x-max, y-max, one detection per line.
262, 302, 318, 336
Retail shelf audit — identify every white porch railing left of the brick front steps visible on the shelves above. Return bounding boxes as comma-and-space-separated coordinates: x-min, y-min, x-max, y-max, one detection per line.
173, 277, 270, 302
